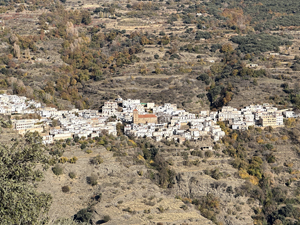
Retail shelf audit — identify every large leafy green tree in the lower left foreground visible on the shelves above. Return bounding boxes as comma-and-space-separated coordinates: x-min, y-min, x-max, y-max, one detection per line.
0, 132, 52, 224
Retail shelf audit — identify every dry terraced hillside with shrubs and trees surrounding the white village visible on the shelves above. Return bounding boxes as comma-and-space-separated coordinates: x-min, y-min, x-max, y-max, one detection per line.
0, 0, 300, 225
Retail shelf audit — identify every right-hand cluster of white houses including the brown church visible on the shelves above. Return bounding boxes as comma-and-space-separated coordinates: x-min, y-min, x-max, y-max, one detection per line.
102, 98, 296, 143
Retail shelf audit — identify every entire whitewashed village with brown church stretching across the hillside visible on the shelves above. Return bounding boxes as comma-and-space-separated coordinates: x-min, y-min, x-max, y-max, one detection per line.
0, 94, 298, 144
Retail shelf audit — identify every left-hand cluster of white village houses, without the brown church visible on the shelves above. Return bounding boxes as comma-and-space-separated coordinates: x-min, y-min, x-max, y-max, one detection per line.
0, 94, 117, 144
